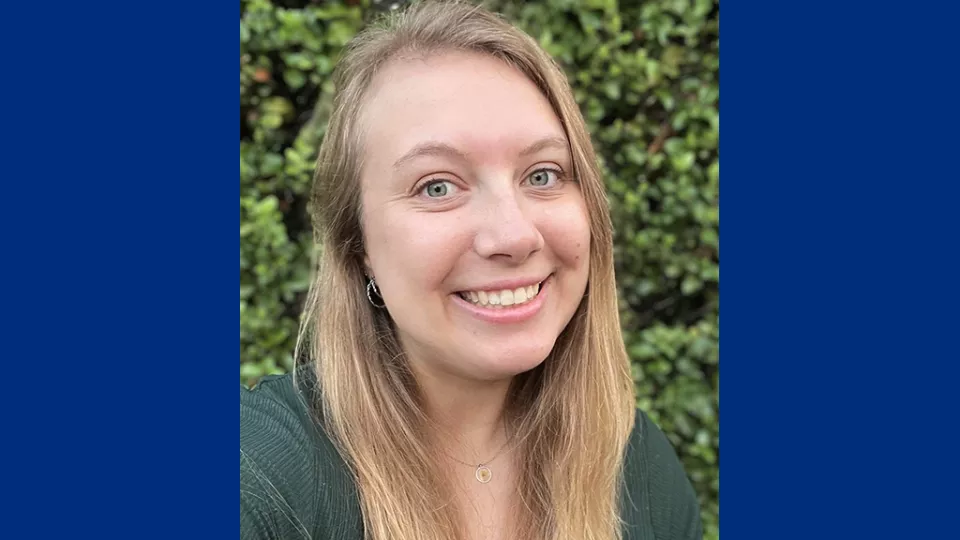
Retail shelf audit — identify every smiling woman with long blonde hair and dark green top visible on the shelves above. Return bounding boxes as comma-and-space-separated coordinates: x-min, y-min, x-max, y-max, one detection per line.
240, 2, 701, 540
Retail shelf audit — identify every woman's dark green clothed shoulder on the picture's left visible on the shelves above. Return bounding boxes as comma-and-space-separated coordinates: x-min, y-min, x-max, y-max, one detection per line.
240, 374, 360, 539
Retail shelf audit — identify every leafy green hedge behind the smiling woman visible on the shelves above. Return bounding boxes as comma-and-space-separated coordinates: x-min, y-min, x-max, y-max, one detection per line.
240, 0, 720, 539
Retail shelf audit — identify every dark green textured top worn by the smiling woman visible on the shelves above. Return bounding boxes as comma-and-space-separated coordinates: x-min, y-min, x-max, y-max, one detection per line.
240, 374, 702, 540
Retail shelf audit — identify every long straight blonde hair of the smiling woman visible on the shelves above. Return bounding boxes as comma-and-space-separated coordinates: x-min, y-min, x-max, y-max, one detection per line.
298, 1, 635, 540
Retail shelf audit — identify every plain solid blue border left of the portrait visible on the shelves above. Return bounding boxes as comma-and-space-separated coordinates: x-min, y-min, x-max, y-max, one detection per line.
0, 2, 239, 539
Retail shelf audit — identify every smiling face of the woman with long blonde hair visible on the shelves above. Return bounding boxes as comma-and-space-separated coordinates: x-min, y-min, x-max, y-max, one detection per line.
362, 49, 590, 381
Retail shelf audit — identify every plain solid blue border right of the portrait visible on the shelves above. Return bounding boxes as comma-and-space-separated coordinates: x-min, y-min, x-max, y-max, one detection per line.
721, 2, 960, 539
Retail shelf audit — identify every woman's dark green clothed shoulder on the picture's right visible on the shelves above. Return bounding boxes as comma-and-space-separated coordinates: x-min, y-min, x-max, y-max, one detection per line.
624, 409, 703, 540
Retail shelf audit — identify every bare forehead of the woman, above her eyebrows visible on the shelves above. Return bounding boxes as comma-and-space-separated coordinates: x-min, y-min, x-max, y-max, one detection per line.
364, 53, 564, 165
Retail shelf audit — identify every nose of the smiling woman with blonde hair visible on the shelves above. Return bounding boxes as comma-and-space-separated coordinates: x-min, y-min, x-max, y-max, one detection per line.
474, 193, 543, 264
